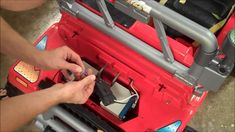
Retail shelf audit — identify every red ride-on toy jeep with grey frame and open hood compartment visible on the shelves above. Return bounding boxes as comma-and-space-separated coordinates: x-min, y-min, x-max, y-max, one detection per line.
6, 0, 235, 132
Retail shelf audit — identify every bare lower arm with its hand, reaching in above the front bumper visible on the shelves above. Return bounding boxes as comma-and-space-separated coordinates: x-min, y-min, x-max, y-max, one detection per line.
0, 73, 96, 132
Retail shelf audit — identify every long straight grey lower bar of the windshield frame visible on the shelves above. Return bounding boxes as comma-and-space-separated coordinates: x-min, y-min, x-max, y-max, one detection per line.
60, 0, 188, 74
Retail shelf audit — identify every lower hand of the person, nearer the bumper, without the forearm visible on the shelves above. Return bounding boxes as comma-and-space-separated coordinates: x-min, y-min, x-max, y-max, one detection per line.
53, 70, 96, 104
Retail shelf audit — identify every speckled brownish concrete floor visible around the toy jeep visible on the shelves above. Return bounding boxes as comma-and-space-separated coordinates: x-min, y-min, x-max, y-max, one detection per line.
0, 0, 235, 132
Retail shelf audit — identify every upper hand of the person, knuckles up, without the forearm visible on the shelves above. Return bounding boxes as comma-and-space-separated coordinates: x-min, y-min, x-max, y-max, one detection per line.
37, 46, 85, 74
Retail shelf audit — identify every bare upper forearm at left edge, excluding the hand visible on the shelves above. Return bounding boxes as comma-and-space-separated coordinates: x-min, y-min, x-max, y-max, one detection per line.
1, 17, 40, 65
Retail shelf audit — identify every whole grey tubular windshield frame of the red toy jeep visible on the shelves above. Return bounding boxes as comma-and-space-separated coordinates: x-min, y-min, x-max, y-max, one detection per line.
58, 0, 226, 90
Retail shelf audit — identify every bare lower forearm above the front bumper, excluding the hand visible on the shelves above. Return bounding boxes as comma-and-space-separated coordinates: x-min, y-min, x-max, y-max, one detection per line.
0, 85, 61, 131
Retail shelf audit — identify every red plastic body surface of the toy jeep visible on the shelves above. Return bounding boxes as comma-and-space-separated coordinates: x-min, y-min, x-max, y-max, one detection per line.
8, 2, 234, 131
